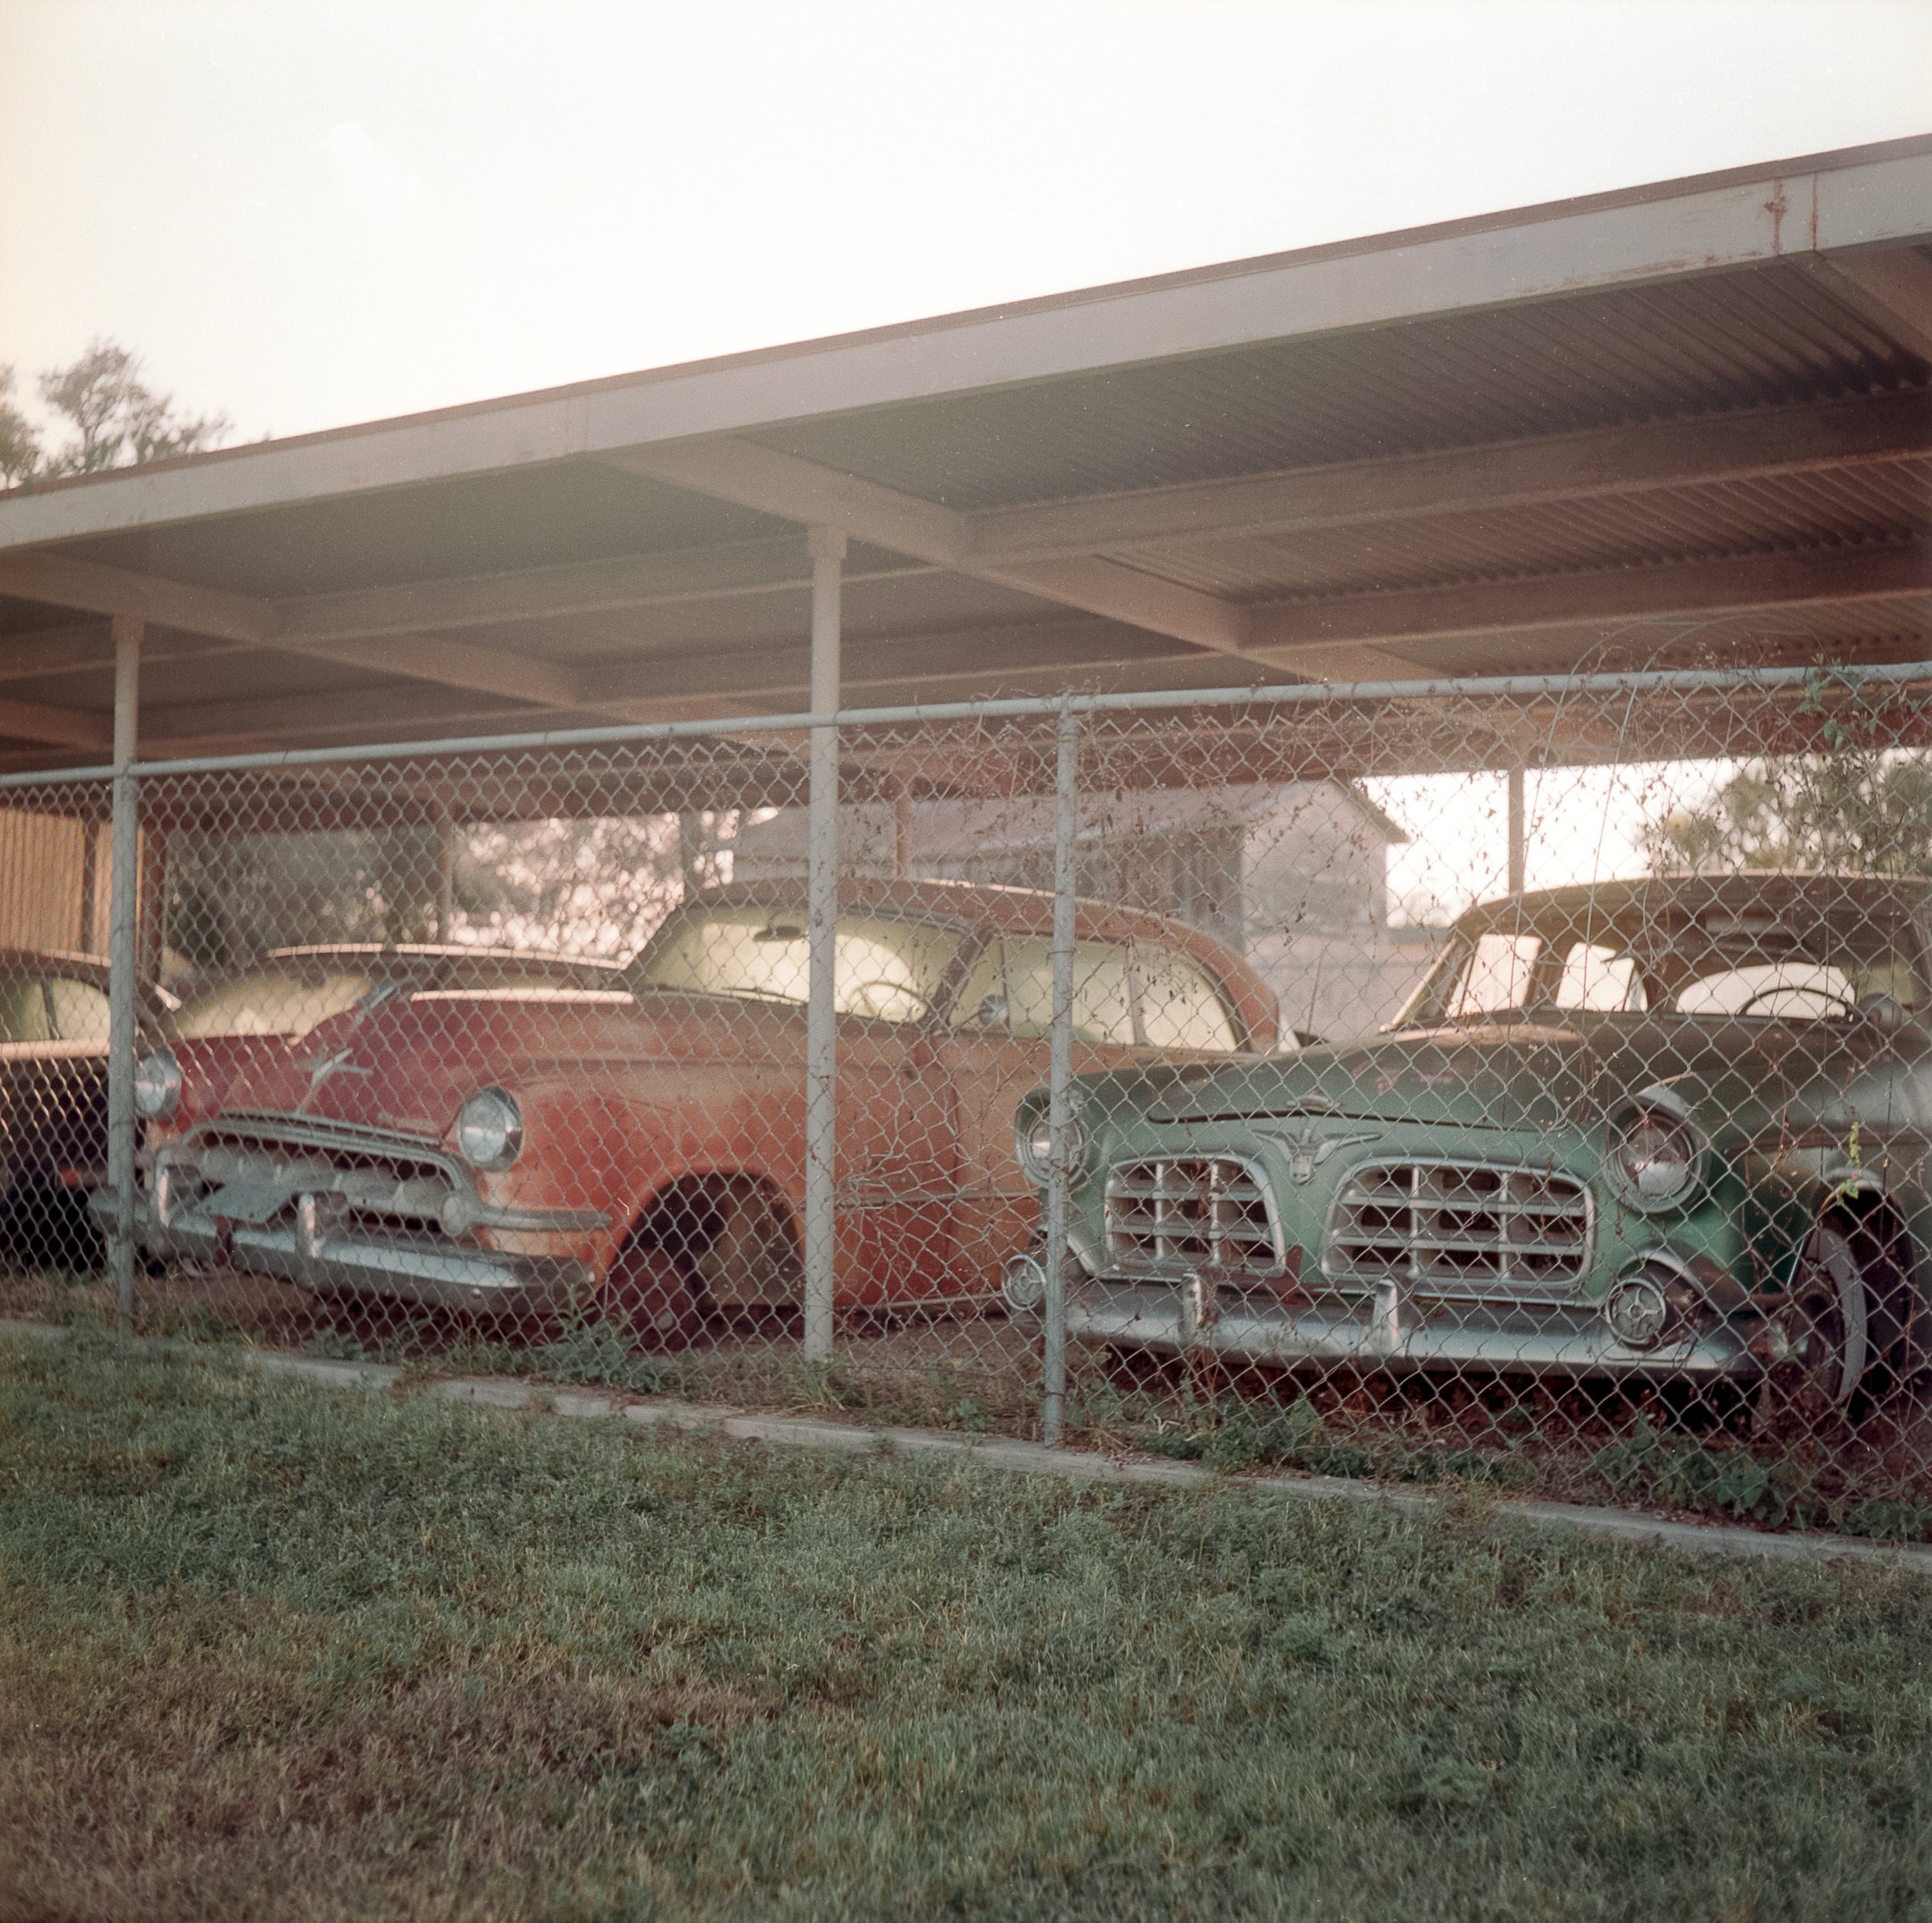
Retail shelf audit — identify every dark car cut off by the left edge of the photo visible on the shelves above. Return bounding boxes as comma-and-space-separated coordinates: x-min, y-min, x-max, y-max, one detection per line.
0, 948, 172, 1266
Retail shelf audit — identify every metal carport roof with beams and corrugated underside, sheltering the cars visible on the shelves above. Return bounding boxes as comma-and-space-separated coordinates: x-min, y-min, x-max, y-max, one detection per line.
0, 137, 1932, 769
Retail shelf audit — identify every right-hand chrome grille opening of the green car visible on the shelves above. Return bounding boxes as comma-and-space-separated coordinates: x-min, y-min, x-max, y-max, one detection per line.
1321, 1158, 1594, 1296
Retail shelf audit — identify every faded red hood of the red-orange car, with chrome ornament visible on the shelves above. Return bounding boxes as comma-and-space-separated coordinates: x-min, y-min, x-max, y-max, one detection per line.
184, 992, 784, 1139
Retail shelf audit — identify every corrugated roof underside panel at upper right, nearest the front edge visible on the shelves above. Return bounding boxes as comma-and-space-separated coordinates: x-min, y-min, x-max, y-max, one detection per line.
756, 263, 1932, 508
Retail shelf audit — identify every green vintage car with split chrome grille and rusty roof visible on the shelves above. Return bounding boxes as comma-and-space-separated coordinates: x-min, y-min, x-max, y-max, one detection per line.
1007, 873, 1932, 1412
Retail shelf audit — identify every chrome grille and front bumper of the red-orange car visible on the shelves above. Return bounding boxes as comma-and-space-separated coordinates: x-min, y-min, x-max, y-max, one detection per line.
91, 1126, 609, 1315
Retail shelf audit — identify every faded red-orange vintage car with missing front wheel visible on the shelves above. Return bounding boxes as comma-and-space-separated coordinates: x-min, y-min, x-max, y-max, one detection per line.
113, 881, 1275, 1340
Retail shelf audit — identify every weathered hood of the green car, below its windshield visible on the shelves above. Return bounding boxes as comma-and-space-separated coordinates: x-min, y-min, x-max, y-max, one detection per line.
1148, 1015, 1928, 1131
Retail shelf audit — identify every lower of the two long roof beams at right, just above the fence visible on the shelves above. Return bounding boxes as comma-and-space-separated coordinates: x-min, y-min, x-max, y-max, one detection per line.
1248, 541, 1932, 668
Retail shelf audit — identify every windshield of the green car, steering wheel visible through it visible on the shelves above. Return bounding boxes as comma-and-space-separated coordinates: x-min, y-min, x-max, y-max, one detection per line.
1401, 896, 1924, 1027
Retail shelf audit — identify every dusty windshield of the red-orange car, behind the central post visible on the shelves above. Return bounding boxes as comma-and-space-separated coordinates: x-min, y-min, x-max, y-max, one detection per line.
628, 908, 961, 1021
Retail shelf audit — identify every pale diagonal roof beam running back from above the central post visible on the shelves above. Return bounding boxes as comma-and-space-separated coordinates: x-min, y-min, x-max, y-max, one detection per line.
607, 437, 1243, 654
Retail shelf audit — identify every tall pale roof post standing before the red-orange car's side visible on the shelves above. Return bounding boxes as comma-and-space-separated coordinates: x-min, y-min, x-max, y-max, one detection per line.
804, 527, 846, 1361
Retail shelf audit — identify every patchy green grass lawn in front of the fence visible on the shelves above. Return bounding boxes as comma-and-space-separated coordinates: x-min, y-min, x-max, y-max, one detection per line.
0, 1334, 1932, 1923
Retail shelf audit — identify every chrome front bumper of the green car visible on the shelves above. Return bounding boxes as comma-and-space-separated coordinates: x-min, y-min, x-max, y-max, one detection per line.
1066, 1276, 1766, 1381
